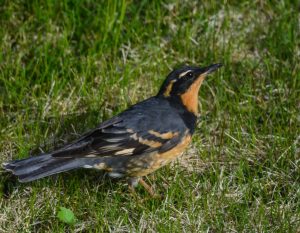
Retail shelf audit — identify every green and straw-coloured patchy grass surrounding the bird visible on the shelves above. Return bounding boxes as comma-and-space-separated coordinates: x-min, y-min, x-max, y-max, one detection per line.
0, 0, 300, 232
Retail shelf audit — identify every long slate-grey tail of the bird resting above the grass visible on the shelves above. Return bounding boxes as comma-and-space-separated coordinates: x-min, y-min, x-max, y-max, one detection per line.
3, 154, 94, 182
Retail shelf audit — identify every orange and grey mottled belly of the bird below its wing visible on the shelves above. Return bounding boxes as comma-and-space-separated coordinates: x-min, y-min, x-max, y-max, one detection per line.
126, 135, 191, 177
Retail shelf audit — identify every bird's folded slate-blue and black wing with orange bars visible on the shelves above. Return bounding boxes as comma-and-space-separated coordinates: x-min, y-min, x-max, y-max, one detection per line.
52, 97, 186, 158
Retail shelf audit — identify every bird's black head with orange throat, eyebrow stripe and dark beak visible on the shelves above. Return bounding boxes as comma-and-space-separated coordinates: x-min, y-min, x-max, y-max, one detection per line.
158, 63, 222, 114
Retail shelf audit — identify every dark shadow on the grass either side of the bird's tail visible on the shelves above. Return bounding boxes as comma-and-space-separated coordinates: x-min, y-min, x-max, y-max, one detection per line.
0, 110, 125, 198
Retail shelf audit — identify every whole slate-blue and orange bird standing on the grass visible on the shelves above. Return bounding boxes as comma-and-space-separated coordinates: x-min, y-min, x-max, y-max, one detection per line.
3, 63, 222, 195
